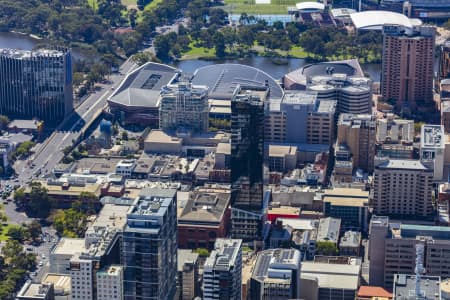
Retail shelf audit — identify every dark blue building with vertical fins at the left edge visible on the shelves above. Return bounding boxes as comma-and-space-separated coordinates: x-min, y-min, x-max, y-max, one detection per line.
0, 47, 73, 124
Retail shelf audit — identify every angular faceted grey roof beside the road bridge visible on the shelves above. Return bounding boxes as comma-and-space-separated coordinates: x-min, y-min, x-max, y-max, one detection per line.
108, 62, 179, 107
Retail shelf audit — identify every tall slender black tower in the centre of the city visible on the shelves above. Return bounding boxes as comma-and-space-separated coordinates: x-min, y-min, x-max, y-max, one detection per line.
230, 87, 269, 239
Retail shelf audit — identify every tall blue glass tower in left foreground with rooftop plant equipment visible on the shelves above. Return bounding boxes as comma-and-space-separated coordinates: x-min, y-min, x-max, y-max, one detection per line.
122, 188, 177, 300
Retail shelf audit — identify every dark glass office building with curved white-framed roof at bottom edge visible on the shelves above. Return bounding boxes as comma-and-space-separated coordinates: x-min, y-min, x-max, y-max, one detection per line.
249, 249, 302, 300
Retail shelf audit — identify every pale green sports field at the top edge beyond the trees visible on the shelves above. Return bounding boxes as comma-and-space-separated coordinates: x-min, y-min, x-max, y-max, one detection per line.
225, 0, 311, 15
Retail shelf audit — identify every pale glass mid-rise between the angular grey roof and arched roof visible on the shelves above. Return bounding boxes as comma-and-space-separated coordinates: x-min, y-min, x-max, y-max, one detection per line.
159, 83, 209, 132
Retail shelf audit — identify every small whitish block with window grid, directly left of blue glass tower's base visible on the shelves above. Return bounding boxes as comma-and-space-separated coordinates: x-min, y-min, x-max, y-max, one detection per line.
97, 265, 123, 300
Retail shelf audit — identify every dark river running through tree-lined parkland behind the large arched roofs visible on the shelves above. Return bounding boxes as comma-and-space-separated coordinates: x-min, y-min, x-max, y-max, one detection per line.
0, 32, 381, 81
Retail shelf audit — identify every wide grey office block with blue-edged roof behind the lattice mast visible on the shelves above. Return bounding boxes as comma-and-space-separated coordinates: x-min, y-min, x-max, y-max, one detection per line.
369, 216, 450, 288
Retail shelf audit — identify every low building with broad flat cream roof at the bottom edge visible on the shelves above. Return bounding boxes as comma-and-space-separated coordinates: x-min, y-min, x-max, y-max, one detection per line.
299, 256, 361, 300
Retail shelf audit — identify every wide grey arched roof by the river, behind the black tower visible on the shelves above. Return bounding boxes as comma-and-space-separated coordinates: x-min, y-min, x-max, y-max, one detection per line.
192, 64, 283, 99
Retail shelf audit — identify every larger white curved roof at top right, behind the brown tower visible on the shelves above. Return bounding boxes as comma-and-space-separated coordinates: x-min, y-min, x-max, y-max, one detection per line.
350, 10, 420, 30
